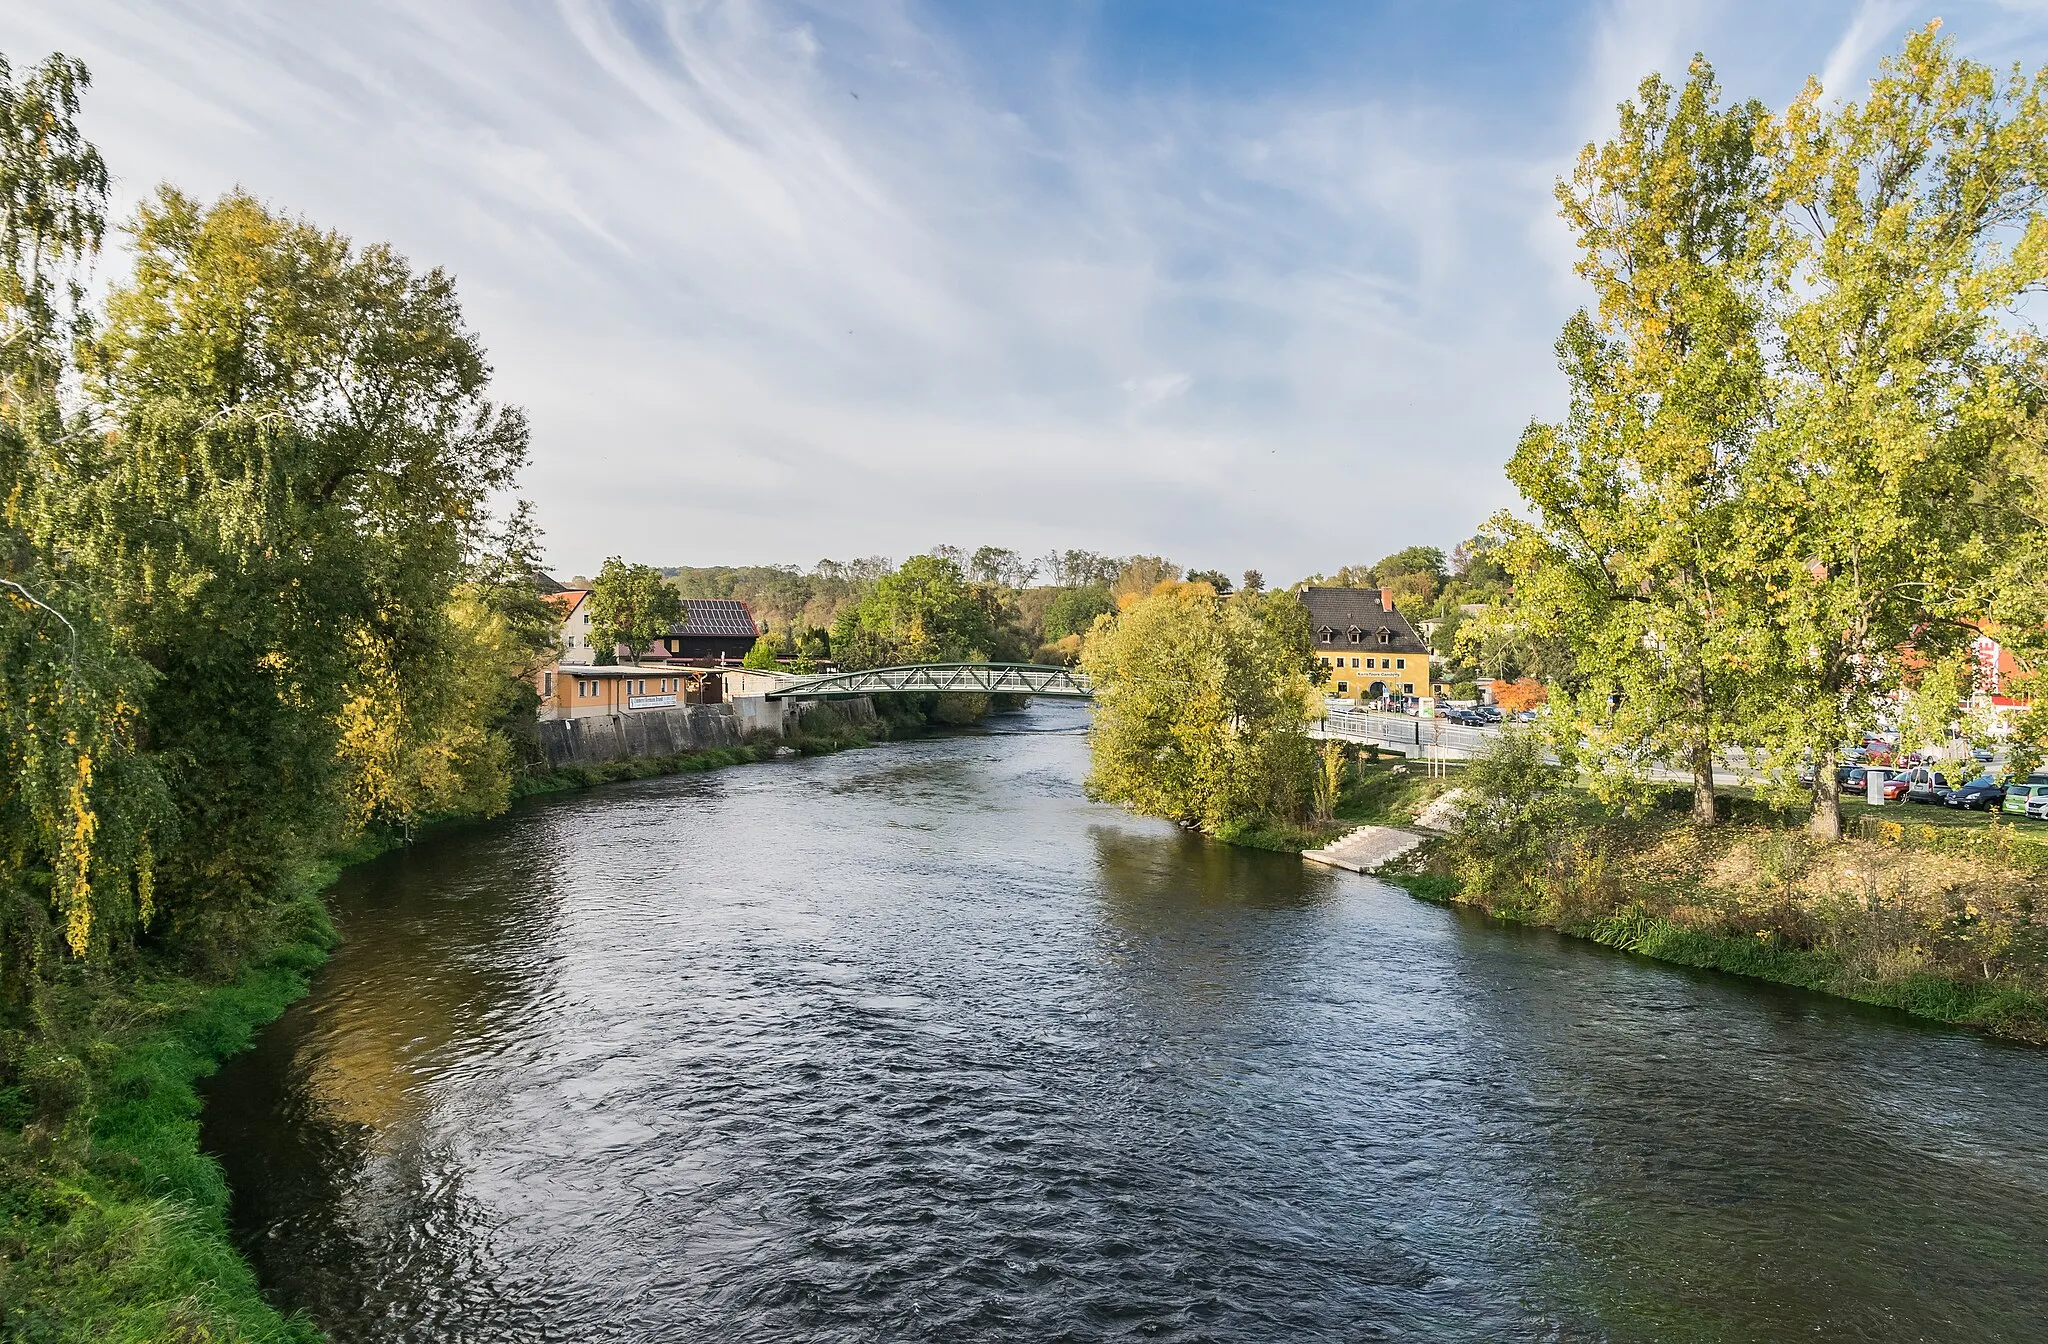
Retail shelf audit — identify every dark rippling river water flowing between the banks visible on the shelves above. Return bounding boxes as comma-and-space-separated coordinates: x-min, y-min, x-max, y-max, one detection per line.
205, 705, 2048, 1342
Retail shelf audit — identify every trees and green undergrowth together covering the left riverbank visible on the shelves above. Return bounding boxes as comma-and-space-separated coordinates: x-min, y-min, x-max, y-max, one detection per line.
0, 57, 555, 1340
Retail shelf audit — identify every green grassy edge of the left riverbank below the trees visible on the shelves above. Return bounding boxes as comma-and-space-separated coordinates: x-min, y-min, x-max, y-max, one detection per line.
0, 713, 903, 1344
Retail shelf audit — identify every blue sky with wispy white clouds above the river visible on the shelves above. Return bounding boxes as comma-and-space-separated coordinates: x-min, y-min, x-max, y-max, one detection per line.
12, 0, 2048, 578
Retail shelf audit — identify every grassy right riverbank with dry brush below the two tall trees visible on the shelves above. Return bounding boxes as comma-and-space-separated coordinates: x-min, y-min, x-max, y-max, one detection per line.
1339, 764, 2048, 1043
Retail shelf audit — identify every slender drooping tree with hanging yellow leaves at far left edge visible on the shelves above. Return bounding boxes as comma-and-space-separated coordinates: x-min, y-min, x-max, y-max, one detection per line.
0, 55, 170, 975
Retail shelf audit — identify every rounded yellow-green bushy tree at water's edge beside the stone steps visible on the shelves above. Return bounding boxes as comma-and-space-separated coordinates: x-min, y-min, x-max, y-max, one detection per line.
1081, 584, 1315, 834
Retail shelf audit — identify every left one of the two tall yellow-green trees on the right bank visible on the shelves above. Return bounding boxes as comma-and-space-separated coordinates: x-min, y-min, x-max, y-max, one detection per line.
1495, 59, 1772, 824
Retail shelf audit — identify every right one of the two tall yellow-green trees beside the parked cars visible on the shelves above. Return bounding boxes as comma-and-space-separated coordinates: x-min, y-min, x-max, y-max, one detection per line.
1739, 25, 2048, 838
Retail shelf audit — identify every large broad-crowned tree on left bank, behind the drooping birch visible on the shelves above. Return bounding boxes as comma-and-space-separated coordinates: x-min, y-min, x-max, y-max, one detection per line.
70, 188, 526, 913
